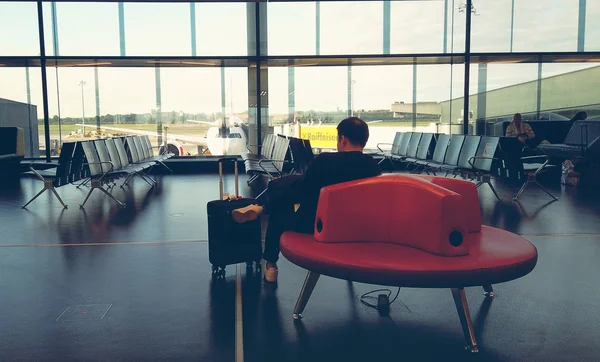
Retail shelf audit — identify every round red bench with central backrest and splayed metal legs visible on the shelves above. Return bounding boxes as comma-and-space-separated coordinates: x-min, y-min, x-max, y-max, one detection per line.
281, 175, 537, 352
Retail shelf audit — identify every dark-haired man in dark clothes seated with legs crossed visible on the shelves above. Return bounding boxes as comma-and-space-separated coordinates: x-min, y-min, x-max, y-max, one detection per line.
232, 117, 381, 282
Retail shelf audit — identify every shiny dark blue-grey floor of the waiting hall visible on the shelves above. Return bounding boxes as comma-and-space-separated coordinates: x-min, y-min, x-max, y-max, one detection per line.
0, 175, 600, 362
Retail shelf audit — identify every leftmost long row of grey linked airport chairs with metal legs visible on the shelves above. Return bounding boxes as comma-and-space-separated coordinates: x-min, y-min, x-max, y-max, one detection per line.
22, 136, 173, 208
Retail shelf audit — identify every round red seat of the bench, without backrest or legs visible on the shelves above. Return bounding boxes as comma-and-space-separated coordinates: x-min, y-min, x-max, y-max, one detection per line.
281, 226, 537, 288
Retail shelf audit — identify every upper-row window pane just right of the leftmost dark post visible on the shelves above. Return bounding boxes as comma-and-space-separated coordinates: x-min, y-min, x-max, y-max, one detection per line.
43, 2, 119, 56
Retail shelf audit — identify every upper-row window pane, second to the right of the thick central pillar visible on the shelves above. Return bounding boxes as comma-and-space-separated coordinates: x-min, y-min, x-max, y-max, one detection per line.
321, 1, 383, 54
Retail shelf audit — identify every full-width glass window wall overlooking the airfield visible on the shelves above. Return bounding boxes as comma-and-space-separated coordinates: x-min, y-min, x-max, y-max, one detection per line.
0, 0, 600, 161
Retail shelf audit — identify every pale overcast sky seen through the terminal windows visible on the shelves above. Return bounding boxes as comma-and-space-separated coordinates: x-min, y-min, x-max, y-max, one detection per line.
0, 0, 600, 117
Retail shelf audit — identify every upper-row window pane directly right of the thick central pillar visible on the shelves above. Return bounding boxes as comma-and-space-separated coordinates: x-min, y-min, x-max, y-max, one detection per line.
267, 2, 317, 55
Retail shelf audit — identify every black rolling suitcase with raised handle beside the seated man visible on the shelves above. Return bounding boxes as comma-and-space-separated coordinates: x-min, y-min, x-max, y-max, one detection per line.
206, 158, 262, 277
